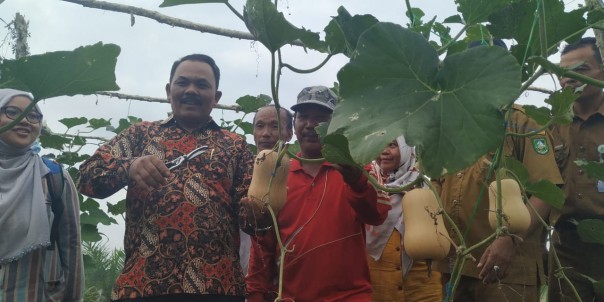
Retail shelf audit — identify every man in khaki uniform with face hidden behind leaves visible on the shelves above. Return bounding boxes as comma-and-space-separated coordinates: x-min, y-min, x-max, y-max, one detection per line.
438, 40, 562, 302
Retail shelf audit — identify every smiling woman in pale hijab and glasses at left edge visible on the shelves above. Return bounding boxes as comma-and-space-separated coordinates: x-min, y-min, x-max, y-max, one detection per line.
0, 89, 83, 302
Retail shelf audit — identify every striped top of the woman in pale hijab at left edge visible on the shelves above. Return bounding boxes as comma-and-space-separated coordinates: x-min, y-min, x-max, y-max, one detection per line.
0, 171, 84, 302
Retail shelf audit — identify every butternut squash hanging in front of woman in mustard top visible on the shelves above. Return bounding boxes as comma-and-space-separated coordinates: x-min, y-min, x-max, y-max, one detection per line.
403, 189, 451, 260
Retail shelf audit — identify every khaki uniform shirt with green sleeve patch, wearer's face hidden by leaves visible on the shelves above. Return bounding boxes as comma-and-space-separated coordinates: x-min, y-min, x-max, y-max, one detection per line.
438, 105, 562, 285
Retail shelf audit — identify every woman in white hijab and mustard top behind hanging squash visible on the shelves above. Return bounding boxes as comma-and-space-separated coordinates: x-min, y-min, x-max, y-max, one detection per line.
366, 136, 443, 302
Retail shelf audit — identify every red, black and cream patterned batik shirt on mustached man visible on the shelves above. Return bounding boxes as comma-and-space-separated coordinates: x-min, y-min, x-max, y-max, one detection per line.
78, 118, 253, 300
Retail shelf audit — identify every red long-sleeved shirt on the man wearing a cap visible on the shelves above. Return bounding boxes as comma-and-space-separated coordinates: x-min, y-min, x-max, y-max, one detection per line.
246, 159, 390, 302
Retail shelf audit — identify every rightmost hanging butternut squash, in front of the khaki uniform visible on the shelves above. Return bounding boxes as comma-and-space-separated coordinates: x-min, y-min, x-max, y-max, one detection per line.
489, 178, 531, 234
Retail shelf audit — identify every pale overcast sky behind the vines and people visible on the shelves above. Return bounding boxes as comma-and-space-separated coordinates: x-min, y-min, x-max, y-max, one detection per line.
0, 0, 568, 250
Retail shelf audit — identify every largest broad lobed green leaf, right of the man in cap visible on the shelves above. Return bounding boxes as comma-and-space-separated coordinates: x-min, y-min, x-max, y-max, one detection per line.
329, 23, 520, 177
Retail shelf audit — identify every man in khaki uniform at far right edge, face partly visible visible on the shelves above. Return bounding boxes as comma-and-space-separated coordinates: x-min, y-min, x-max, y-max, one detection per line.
549, 38, 604, 302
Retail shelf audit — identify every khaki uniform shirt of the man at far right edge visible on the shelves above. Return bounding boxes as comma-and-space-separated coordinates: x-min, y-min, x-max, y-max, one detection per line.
551, 103, 604, 222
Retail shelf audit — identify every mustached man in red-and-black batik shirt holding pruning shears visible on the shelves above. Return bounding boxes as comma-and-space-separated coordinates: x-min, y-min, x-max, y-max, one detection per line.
78, 54, 253, 302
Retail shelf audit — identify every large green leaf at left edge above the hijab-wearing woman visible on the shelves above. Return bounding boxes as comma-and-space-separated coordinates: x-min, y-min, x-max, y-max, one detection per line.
0, 42, 120, 100
